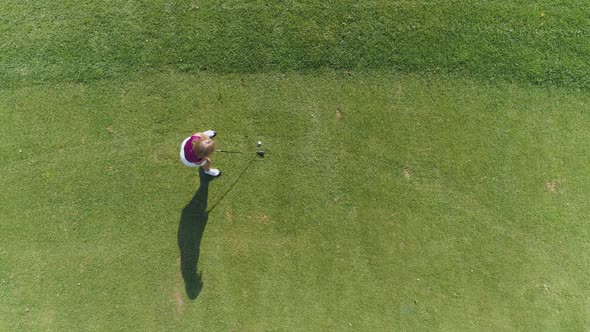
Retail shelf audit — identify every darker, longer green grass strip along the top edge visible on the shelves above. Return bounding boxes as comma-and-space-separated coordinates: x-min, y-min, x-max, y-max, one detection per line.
0, 0, 590, 89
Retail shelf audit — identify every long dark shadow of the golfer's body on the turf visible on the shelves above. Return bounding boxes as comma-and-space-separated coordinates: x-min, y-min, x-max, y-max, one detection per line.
178, 169, 212, 300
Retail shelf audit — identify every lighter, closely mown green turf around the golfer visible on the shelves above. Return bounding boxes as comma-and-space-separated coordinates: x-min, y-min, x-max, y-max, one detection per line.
0, 72, 590, 330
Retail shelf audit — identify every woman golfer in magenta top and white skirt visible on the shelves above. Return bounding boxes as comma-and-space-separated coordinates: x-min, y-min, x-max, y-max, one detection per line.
180, 130, 221, 177
